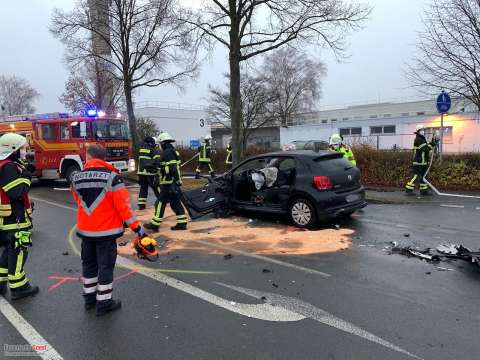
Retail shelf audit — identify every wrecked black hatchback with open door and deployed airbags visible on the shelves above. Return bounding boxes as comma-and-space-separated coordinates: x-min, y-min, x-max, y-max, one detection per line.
183, 150, 367, 228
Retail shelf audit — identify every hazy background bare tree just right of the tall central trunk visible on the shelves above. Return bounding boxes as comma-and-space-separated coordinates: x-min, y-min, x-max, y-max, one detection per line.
261, 47, 326, 126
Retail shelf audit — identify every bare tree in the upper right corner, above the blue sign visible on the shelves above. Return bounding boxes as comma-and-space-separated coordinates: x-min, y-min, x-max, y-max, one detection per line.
407, 0, 480, 111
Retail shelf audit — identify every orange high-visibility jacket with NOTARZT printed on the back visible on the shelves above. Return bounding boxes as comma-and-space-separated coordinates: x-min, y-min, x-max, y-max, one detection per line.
71, 159, 140, 238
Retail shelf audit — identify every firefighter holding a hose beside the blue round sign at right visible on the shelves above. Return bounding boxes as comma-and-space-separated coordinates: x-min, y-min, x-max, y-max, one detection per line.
405, 124, 437, 195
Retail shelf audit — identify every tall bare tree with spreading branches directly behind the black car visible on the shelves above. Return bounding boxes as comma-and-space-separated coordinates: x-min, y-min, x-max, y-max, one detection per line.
187, 0, 370, 163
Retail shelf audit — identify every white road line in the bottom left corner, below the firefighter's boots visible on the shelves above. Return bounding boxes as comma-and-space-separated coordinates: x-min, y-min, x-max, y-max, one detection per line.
0, 296, 63, 360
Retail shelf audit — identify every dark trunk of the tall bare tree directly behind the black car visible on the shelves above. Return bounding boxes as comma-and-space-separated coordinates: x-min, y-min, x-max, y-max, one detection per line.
229, 15, 245, 165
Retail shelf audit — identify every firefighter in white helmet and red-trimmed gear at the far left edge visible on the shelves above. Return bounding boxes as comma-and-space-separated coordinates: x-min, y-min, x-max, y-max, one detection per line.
0, 133, 39, 300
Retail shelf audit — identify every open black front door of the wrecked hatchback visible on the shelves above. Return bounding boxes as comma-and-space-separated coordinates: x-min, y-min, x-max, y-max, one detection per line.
182, 177, 231, 220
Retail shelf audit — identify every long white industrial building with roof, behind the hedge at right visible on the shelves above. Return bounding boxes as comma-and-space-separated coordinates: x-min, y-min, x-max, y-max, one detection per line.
280, 100, 480, 153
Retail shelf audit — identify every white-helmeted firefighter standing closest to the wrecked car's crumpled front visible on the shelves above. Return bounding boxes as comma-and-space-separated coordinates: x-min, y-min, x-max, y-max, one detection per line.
145, 132, 187, 231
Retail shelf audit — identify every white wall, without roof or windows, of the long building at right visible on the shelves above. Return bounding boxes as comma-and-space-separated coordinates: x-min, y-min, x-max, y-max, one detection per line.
280, 113, 480, 153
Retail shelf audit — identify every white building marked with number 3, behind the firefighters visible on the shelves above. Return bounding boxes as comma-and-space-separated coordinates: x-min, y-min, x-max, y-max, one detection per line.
135, 101, 211, 147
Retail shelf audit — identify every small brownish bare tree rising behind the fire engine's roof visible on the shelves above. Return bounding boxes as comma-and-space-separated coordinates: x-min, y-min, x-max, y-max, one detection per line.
59, 59, 125, 114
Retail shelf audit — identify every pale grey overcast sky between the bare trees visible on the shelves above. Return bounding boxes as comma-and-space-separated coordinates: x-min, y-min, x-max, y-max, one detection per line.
0, 0, 428, 112
